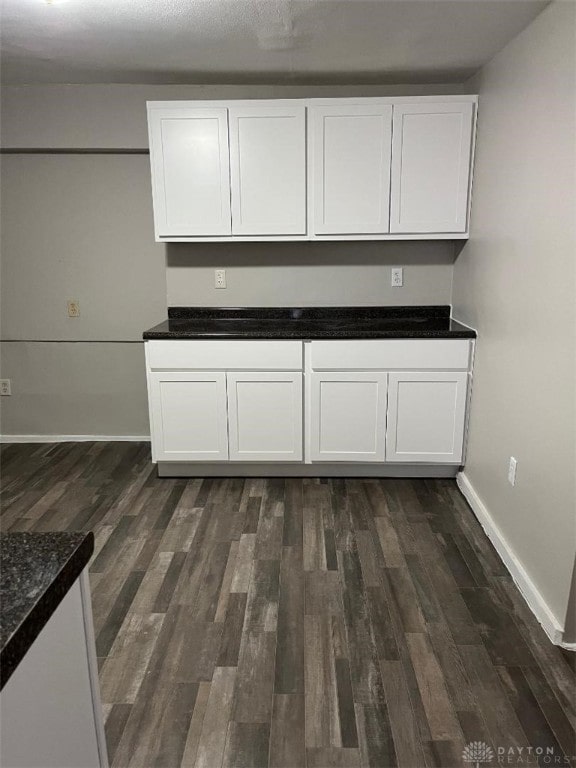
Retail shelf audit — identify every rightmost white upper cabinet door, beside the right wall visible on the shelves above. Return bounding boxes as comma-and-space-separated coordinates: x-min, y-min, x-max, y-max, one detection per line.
390, 102, 474, 233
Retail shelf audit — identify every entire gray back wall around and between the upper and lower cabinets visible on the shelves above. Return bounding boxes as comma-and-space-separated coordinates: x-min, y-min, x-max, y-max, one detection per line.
0, 85, 462, 435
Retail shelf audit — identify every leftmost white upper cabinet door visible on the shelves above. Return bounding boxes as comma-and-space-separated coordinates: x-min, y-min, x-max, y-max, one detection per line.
149, 108, 231, 237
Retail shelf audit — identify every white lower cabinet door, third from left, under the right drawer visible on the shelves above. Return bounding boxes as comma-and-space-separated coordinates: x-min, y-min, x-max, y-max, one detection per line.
309, 371, 387, 462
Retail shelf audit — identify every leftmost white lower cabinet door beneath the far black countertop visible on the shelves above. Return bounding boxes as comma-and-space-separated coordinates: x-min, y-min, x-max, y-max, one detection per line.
149, 371, 228, 461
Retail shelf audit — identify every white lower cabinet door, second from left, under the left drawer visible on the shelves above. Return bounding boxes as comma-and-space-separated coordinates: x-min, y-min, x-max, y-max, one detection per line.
227, 371, 302, 461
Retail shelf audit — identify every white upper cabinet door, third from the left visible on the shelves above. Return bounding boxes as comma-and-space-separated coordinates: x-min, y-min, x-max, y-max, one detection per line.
310, 102, 392, 235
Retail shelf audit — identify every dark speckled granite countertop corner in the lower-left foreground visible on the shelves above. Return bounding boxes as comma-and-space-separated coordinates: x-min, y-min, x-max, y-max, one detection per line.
0, 533, 94, 689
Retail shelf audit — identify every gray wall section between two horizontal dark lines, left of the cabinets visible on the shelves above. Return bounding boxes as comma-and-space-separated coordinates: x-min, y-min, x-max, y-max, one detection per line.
0, 154, 166, 341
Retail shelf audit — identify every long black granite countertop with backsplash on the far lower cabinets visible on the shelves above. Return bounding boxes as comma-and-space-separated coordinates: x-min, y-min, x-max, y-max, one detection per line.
143, 306, 476, 339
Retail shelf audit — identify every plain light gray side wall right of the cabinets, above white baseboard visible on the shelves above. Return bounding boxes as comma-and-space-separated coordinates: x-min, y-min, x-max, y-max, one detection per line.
453, 2, 576, 626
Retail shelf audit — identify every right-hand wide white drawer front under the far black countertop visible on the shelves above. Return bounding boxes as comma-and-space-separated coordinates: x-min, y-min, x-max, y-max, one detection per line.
310, 339, 471, 371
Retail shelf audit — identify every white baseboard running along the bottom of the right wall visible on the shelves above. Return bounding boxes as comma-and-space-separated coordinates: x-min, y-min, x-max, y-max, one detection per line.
456, 472, 564, 649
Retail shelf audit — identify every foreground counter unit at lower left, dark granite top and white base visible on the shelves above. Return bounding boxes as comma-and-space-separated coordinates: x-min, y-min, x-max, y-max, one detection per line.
0, 532, 108, 768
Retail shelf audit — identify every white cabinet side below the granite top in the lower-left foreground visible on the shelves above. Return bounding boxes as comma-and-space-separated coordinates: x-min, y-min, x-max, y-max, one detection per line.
0, 568, 108, 768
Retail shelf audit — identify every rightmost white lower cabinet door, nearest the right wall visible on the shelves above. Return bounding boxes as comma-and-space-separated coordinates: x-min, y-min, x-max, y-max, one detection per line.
386, 371, 468, 464
